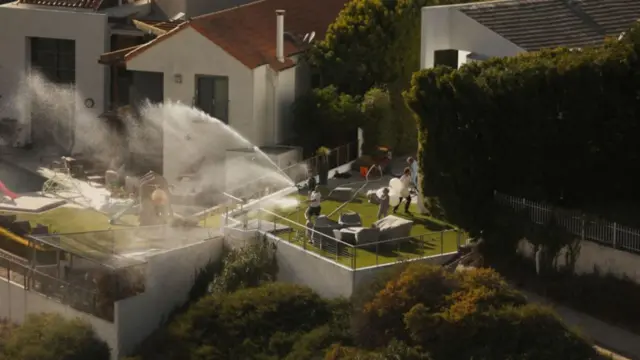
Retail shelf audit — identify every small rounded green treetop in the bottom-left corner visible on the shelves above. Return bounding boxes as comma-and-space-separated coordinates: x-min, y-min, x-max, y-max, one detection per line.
2, 314, 110, 360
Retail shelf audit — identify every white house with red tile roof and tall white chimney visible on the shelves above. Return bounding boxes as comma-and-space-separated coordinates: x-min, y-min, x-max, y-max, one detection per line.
107, 0, 346, 181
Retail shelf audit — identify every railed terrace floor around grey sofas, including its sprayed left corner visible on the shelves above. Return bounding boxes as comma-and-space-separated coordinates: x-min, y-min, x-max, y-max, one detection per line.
225, 190, 465, 269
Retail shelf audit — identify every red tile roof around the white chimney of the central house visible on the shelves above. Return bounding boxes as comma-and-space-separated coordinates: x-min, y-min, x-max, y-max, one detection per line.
125, 0, 348, 70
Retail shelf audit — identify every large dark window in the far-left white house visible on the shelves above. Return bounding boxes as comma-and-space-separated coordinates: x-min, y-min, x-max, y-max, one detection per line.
31, 38, 76, 84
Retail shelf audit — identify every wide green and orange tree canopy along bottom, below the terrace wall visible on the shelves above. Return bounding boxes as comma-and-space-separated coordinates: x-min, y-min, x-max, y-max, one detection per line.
127, 255, 595, 360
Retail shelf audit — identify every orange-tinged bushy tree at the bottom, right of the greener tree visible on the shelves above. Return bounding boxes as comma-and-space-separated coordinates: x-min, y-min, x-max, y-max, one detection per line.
356, 264, 595, 360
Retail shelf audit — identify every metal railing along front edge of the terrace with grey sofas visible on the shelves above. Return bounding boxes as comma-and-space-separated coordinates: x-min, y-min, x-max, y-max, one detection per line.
258, 209, 462, 269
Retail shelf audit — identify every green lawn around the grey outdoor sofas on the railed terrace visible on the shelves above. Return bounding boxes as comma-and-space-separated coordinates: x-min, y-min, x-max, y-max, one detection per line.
264, 196, 464, 268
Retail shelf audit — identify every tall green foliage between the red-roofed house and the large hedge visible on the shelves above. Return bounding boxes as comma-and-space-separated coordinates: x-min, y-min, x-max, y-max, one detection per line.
295, 0, 482, 154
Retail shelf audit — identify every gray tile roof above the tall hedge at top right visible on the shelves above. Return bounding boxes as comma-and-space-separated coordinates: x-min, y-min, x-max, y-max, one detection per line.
457, 0, 640, 51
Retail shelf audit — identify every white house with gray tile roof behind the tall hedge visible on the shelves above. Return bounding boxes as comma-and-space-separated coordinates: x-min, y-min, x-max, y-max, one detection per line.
420, 0, 640, 68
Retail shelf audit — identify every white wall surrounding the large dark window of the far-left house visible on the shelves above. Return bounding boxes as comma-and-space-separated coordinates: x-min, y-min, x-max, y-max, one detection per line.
0, 3, 110, 143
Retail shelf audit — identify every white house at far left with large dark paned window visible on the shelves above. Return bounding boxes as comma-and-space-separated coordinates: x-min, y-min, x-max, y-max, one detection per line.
0, 0, 260, 150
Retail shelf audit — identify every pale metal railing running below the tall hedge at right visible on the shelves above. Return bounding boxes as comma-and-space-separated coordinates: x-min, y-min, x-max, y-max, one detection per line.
494, 192, 640, 254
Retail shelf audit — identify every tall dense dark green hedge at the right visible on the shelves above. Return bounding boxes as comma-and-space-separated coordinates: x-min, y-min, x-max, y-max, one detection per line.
405, 26, 640, 229
